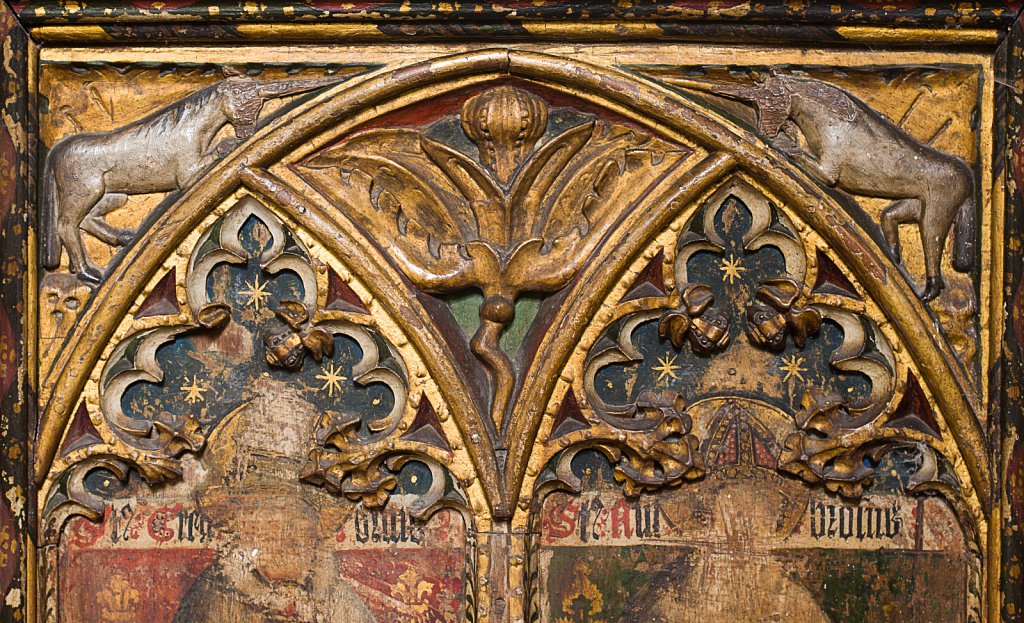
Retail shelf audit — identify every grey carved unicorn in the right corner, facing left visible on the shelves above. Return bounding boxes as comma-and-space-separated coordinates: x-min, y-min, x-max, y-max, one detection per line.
713, 74, 977, 301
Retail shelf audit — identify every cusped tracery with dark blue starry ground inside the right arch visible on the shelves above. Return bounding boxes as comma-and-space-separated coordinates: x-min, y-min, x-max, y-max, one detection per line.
540, 179, 959, 510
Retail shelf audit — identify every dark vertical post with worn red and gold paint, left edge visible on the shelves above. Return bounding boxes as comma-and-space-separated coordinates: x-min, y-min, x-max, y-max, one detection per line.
0, 4, 36, 622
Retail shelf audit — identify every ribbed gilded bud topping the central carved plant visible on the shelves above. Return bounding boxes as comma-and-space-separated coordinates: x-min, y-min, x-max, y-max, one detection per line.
462, 86, 548, 184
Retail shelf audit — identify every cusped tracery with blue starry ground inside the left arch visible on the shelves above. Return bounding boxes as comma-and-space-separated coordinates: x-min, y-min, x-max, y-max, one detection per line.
45, 198, 466, 538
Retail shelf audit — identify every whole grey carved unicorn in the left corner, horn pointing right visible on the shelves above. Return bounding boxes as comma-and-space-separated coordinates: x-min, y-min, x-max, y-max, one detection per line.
40, 69, 338, 283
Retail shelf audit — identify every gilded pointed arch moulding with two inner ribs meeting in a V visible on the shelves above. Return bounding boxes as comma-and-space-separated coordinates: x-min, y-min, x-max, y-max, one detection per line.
35, 49, 990, 516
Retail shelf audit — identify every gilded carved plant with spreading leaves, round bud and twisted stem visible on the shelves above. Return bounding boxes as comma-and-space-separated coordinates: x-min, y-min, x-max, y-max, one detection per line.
298, 86, 690, 429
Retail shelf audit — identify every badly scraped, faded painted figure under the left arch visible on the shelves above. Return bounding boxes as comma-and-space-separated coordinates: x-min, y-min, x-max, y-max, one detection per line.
174, 381, 375, 623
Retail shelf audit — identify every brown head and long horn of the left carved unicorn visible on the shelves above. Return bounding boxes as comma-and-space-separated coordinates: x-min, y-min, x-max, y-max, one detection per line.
217, 67, 339, 140
